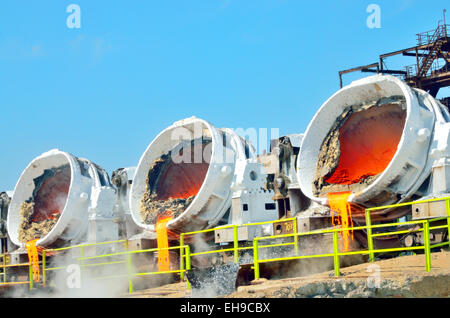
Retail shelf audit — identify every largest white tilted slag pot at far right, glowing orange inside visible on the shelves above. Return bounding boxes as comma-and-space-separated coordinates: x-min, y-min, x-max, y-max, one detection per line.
297, 75, 450, 248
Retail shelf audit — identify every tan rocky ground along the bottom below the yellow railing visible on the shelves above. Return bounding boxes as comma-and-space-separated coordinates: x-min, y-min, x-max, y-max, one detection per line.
128, 251, 450, 298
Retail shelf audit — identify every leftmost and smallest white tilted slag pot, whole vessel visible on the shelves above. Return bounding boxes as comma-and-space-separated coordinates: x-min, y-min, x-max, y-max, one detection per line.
7, 149, 119, 264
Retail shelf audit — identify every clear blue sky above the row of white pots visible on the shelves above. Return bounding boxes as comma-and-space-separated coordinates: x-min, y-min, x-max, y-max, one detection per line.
0, 0, 450, 191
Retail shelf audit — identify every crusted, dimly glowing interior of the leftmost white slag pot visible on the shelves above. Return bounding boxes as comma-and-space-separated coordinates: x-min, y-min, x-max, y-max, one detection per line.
19, 165, 71, 243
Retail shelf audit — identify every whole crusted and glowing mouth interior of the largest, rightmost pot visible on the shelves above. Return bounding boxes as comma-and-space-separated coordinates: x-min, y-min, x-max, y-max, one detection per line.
313, 96, 406, 197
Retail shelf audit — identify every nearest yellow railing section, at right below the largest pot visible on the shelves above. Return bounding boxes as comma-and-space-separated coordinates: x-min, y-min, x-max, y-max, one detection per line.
253, 197, 450, 279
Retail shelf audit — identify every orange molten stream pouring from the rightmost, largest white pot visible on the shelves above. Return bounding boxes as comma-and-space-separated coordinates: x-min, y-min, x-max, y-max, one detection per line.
328, 191, 353, 252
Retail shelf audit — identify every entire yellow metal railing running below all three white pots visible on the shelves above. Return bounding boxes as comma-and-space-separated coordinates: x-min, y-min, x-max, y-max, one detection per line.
18, 197, 450, 293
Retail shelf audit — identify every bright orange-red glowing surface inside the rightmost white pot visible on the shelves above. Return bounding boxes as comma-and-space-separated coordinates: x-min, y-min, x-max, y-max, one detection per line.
325, 104, 406, 184
